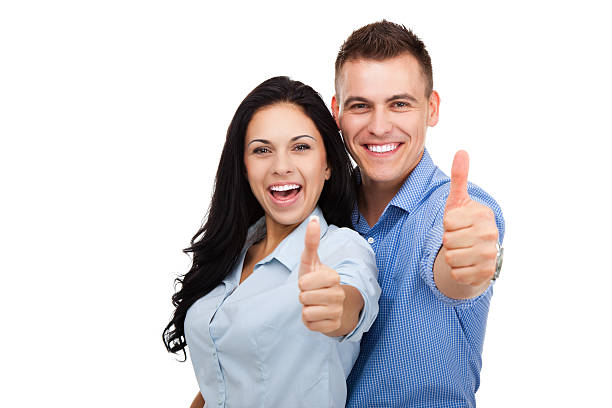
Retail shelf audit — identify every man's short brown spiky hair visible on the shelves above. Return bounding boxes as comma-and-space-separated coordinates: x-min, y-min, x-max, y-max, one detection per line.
335, 20, 433, 97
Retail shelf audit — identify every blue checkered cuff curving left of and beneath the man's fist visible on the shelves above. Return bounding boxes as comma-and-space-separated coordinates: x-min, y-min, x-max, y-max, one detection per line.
419, 223, 493, 307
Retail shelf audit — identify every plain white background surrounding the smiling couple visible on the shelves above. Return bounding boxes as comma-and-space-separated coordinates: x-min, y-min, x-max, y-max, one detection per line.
0, 0, 612, 407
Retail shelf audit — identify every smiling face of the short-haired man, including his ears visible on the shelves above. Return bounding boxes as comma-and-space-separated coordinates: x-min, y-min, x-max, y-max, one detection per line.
332, 54, 439, 187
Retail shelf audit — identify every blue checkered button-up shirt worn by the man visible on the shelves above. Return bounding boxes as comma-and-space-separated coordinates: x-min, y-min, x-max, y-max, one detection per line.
347, 150, 504, 408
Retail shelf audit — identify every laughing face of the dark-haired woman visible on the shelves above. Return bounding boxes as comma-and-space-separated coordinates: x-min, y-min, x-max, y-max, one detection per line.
244, 103, 331, 230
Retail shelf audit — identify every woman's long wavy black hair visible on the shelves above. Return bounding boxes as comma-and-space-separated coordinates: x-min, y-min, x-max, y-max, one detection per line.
162, 76, 355, 353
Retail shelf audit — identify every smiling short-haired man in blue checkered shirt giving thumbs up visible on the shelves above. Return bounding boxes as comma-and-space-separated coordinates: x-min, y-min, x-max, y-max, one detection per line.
332, 20, 504, 407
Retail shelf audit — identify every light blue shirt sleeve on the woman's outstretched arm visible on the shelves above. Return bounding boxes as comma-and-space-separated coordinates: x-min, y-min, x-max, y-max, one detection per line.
323, 228, 381, 342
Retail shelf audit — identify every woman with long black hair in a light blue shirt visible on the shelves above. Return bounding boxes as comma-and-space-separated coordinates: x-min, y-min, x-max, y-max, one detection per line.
163, 77, 380, 407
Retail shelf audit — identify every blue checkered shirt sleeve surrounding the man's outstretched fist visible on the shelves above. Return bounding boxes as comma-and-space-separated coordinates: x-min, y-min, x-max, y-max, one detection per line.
419, 183, 505, 307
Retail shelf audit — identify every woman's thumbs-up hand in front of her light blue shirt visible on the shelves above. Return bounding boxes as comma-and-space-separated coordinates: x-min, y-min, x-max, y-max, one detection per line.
298, 216, 346, 336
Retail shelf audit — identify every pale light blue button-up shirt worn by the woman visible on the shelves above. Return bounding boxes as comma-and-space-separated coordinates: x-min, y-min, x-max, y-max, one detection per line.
185, 208, 380, 408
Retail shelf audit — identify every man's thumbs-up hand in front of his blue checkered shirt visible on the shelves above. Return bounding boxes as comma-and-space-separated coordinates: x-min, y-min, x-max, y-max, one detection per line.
434, 150, 498, 290
